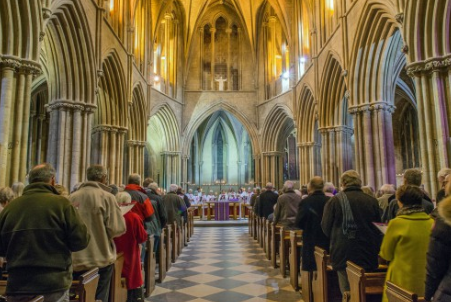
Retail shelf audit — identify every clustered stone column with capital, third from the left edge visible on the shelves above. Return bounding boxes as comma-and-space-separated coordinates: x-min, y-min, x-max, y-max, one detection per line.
91, 125, 127, 185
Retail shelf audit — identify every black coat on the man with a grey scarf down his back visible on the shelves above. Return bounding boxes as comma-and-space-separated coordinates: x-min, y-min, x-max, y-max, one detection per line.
321, 187, 382, 271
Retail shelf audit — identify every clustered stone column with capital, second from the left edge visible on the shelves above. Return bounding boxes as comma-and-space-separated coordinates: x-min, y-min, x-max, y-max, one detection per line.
46, 101, 97, 189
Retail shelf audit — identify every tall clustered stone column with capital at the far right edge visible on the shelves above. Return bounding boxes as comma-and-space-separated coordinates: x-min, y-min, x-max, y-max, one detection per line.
407, 55, 451, 197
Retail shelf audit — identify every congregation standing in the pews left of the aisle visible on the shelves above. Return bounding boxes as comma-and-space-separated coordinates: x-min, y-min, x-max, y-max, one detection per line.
0, 163, 190, 302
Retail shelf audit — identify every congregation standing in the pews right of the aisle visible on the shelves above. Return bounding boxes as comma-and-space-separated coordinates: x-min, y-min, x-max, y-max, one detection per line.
250, 168, 451, 302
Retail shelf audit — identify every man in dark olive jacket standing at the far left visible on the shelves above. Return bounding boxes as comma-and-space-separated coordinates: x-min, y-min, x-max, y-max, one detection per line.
0, 164, 92, 302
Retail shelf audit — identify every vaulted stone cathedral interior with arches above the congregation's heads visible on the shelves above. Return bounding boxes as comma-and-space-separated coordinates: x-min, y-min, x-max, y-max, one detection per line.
0, 0, 451, 196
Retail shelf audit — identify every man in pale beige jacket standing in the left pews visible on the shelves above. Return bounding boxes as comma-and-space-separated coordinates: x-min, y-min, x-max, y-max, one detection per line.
69, 165, 126, 302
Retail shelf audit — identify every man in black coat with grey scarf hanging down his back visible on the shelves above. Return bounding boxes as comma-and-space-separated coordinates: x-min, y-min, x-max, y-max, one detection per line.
321, 170, 382, 294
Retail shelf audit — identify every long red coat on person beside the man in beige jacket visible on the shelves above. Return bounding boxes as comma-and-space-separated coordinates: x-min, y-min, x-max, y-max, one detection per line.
114, 212, 147, 289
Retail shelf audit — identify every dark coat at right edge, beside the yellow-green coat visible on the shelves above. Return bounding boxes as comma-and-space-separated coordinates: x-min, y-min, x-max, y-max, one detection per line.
424, 218, 451, 302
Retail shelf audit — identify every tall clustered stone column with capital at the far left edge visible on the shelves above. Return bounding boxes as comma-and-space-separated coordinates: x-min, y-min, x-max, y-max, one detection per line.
0, 55, 41, 187
